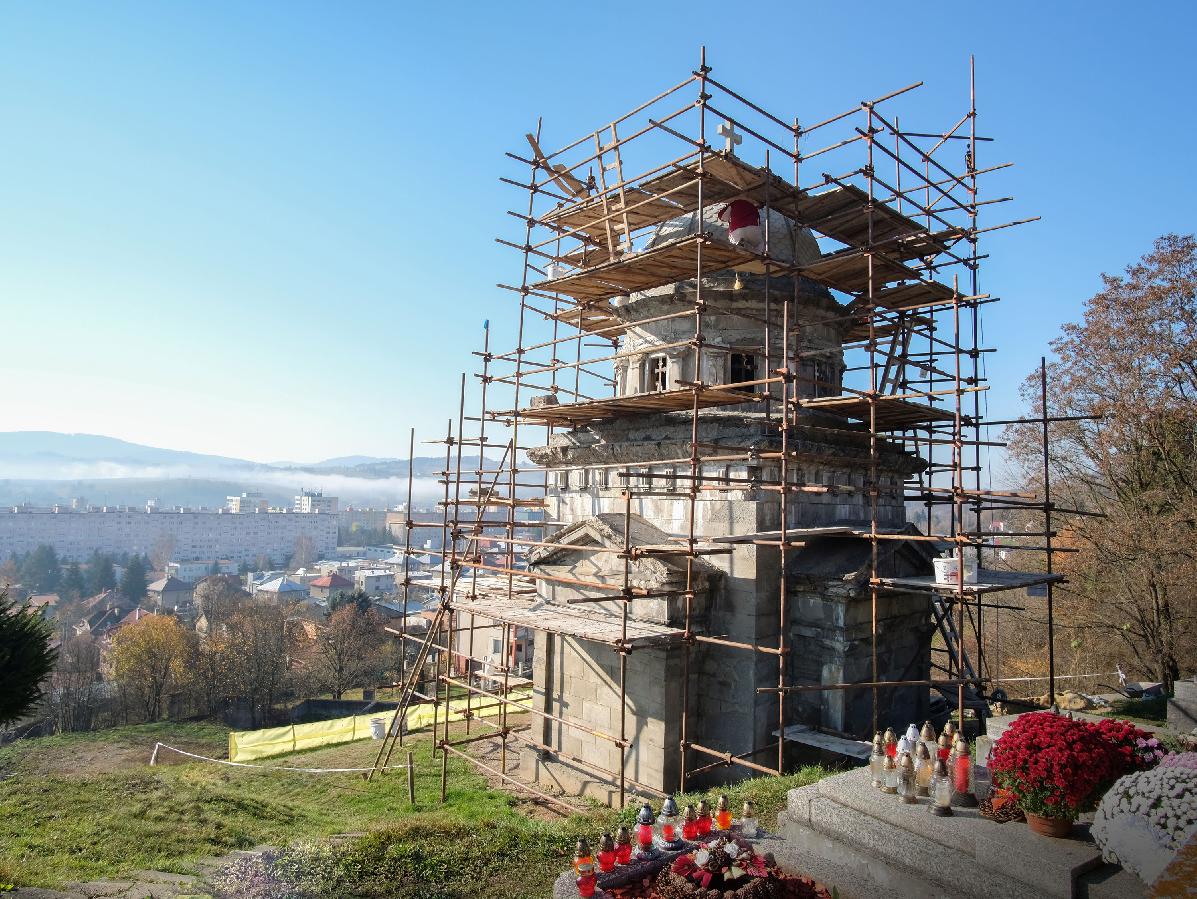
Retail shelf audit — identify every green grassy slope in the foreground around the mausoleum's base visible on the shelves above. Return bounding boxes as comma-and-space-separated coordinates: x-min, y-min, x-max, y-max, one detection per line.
0, 724, 828, 899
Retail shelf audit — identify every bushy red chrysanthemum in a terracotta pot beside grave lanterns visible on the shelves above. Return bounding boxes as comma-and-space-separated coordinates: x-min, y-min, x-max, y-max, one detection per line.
990, 712, 1122, 837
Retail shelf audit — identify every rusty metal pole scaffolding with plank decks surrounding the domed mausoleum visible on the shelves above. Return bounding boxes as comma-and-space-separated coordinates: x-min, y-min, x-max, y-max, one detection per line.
363, 49, 1063, 804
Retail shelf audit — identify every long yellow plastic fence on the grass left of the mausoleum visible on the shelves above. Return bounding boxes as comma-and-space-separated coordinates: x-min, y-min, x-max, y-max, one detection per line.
229, 690, 531, 761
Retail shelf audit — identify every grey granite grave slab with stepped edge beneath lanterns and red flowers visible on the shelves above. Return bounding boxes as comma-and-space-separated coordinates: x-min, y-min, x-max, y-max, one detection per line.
771, 769, 1146, 899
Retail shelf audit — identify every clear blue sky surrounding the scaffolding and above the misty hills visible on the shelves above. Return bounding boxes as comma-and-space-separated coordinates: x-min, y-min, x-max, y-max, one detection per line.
0, 2, 1197, 471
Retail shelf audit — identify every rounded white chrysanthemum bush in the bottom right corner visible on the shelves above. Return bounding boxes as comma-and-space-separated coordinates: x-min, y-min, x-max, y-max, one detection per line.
1092, 767, 1197, 883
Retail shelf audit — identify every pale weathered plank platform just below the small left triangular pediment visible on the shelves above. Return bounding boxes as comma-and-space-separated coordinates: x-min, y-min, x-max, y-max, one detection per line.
452, 596, 685, 648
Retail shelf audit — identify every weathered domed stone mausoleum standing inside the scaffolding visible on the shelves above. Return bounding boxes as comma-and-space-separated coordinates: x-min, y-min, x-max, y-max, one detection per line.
522, 211, 932, 800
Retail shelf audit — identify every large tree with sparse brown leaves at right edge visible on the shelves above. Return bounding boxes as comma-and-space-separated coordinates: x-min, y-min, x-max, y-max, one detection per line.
1010, 235, 1197, 688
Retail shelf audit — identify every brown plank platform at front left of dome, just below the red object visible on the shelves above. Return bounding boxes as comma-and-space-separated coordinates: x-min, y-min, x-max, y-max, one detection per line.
531, 235, 760, 300
